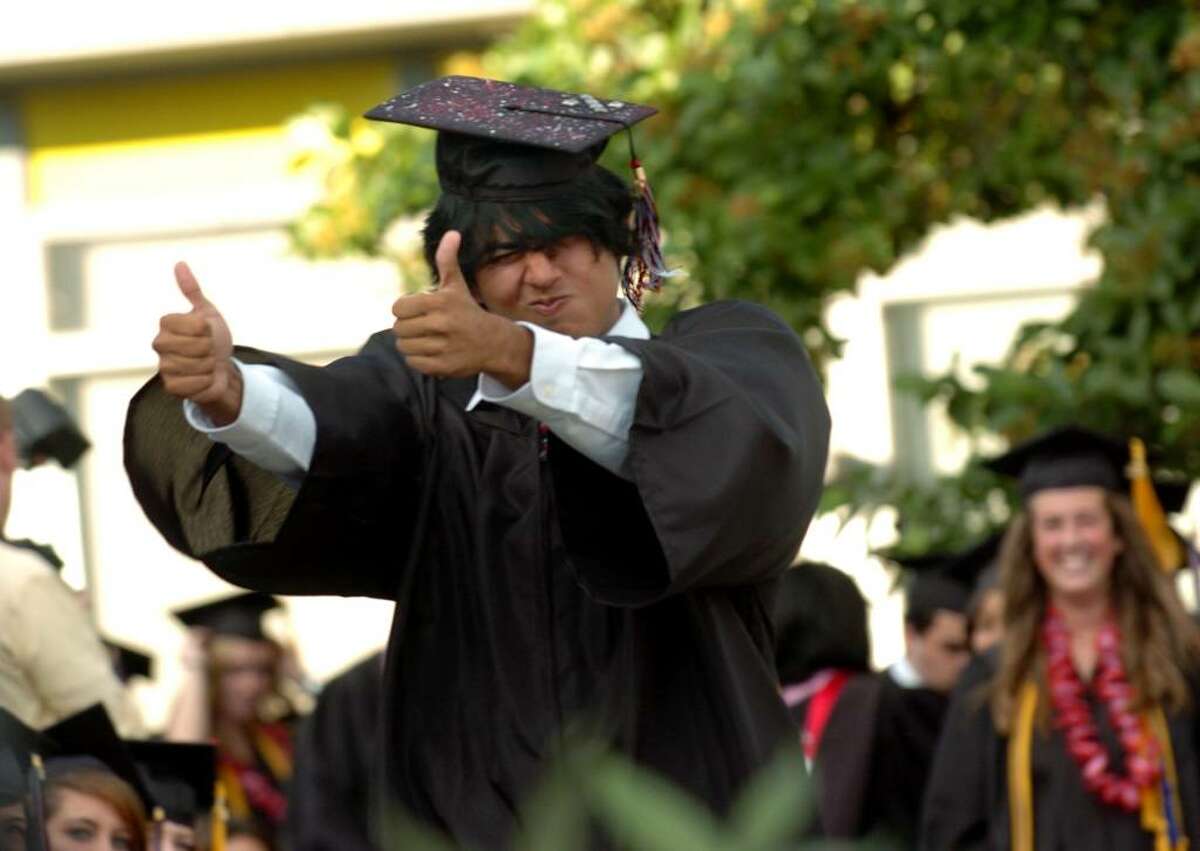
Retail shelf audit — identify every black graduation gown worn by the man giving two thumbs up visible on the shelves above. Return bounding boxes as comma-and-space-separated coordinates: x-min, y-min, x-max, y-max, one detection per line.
126, 302, 829, 846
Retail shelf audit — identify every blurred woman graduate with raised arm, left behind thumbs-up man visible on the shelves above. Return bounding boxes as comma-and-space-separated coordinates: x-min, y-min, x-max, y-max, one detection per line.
166, 593, 294, 838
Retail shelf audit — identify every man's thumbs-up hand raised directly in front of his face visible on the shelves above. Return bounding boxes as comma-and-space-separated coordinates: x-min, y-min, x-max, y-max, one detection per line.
391, 230, 533, 389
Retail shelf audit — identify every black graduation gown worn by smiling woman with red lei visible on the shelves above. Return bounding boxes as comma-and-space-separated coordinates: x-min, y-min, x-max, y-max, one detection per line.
922, 654, 1200, 851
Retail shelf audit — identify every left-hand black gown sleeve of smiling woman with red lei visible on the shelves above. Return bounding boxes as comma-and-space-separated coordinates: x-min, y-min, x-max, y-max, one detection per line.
920, 658, 998, 851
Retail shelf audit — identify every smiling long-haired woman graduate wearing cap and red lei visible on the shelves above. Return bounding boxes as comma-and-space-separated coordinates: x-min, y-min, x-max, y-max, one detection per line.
922, 427, 1200, 851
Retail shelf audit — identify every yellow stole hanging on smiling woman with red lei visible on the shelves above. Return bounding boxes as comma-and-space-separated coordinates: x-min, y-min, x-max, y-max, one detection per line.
1008, 679, 1188, 851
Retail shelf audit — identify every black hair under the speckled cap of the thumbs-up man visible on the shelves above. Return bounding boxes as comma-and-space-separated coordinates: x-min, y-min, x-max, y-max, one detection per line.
424, 160, 634, 287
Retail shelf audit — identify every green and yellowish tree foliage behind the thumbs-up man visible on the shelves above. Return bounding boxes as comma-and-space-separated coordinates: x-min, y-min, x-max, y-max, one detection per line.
294, 0, 1200, 549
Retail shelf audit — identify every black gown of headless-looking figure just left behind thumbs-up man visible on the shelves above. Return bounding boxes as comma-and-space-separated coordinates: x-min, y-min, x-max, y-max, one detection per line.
287, 653, 383, 851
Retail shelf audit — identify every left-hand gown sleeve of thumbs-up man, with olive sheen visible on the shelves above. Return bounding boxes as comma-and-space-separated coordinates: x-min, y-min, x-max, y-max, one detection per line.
125, 332, 437, 599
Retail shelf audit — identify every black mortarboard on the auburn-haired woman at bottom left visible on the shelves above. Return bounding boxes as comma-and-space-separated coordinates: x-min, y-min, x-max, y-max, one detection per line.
42, 703, 155, 814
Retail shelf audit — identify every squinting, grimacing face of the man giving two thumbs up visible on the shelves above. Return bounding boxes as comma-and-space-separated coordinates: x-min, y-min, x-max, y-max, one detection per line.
475, 236, 620, 337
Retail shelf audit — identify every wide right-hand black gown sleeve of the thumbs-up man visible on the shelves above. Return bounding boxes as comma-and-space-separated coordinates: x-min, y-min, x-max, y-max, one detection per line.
548, 301, 829, 606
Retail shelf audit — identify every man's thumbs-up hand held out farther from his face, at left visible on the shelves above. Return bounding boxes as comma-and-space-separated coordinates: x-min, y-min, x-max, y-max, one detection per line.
154, 263, 241, 426
